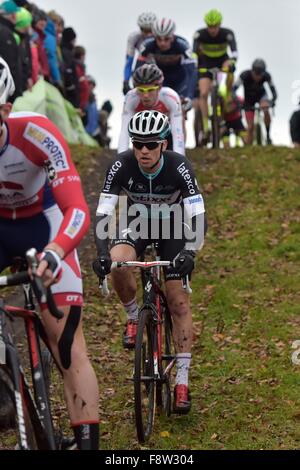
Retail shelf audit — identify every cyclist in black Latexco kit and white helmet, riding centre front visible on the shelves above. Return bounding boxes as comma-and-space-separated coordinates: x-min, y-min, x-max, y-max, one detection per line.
93, 110, 205, 413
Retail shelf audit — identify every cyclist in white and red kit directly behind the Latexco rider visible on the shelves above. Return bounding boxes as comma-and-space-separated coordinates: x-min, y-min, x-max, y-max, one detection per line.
118, 64, 185, 155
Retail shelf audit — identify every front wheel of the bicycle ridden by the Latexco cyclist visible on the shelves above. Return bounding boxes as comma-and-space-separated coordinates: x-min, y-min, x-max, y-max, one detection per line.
134, 309, 155, 443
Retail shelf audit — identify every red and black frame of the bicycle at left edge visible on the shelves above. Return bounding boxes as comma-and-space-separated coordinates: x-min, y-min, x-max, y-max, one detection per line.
0, 286, 56, 450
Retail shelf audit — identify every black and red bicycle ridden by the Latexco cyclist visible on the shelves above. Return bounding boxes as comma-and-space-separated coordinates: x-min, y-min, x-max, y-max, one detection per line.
102, 253, 191, 443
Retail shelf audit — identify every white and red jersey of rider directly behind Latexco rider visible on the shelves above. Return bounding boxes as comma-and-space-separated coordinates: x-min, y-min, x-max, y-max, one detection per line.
118, 87, 185, 155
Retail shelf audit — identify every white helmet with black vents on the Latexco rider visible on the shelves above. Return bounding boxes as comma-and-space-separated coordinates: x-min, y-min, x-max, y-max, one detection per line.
128, 111, 171, 142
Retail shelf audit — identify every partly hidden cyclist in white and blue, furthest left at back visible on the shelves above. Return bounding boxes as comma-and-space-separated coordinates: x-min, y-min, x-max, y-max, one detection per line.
123, 13, 156, 95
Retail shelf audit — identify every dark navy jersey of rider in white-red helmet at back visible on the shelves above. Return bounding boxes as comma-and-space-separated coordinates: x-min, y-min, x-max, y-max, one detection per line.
136, 36, 197, 99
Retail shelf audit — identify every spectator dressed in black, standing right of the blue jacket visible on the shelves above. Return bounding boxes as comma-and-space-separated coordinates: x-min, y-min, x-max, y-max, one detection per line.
61, 28, 80, 108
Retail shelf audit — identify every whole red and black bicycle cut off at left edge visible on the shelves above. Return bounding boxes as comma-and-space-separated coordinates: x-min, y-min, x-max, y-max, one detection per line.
0, 249, 63, 450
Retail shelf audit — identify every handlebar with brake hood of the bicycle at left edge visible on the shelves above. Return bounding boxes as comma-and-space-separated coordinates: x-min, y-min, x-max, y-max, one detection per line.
0, 248, 64, 320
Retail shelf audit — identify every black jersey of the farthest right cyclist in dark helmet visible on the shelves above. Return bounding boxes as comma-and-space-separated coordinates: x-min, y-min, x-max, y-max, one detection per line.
233, 70, 277, 106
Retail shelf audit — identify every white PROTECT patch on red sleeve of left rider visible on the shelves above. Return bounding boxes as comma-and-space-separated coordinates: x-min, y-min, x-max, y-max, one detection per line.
24, 122, 70, 173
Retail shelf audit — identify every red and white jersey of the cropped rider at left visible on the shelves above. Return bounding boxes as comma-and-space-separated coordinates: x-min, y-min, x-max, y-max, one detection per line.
0, 113, 90, 254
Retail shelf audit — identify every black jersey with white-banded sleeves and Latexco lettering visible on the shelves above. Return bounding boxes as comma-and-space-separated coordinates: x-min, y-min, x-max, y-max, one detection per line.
96, 150, 205, 264
